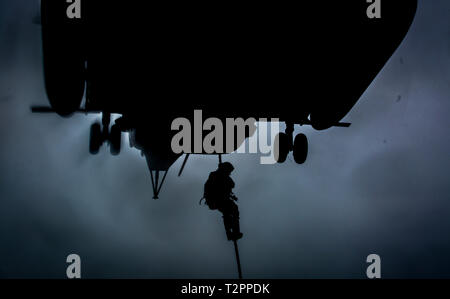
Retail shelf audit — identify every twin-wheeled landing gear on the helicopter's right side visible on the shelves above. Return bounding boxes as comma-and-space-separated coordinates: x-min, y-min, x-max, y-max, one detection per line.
275, 122, 308, 164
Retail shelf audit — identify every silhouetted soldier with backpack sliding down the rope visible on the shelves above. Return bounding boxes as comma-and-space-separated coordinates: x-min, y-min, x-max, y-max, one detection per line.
202, 162, 243, 241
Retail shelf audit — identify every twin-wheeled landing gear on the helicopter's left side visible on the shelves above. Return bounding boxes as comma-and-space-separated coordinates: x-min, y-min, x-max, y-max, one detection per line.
89, 113, 122, 156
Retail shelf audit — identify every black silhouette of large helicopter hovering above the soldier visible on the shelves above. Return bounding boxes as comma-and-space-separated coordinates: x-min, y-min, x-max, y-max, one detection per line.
32, 0, 417, 199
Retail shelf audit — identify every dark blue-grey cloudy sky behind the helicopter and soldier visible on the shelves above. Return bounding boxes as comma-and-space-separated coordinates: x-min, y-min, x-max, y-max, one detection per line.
0, 0, 450, 278
